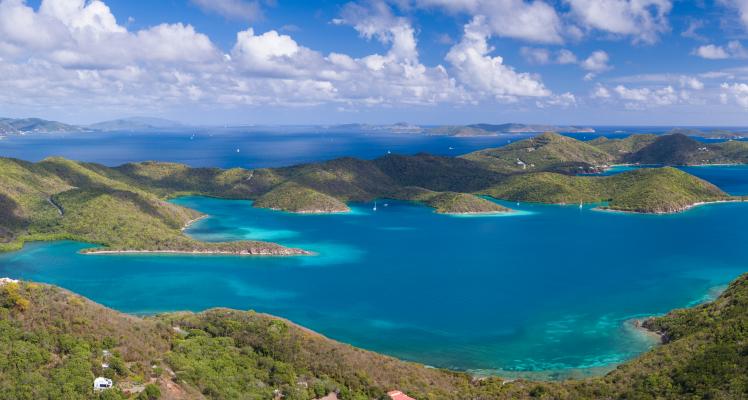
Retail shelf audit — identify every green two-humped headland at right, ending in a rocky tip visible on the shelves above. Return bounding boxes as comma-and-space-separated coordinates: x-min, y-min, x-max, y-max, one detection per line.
481, 167, 730, 213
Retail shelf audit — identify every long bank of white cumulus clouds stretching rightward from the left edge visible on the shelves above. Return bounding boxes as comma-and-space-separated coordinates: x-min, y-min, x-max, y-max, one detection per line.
0, 0, 576, 114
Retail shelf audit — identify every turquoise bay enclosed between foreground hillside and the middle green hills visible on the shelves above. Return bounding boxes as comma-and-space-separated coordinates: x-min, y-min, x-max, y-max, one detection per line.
0, 191, 748, 377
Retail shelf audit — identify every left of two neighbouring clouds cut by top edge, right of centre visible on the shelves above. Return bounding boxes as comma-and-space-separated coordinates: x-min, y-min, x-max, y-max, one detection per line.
414, 0, 565, 43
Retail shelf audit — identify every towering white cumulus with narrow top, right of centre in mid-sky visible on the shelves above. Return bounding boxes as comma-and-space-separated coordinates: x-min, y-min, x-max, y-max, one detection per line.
446, 16, 551, 100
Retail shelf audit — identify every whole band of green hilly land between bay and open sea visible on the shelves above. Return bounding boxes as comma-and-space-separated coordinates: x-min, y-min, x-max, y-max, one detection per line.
0, 133, 748, 255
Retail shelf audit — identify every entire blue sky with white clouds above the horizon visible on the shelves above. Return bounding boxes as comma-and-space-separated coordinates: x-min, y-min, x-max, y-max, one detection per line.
0, 0, 748, 126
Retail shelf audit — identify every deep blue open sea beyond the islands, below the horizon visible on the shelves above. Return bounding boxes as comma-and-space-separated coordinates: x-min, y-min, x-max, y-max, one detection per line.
0, 127, 744, 168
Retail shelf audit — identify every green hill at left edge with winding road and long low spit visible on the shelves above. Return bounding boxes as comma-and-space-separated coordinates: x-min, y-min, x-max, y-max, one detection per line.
0, 158, 300, 254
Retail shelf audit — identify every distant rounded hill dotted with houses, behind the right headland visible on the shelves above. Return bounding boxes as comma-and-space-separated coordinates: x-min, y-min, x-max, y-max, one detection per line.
462, 132, 614, 173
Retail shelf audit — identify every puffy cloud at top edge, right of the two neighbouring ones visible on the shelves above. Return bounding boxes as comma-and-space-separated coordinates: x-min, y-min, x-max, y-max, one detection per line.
566, 0, 672, 43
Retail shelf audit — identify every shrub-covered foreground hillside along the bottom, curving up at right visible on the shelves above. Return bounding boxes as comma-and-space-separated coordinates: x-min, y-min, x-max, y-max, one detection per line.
0, 275, 748, 399
